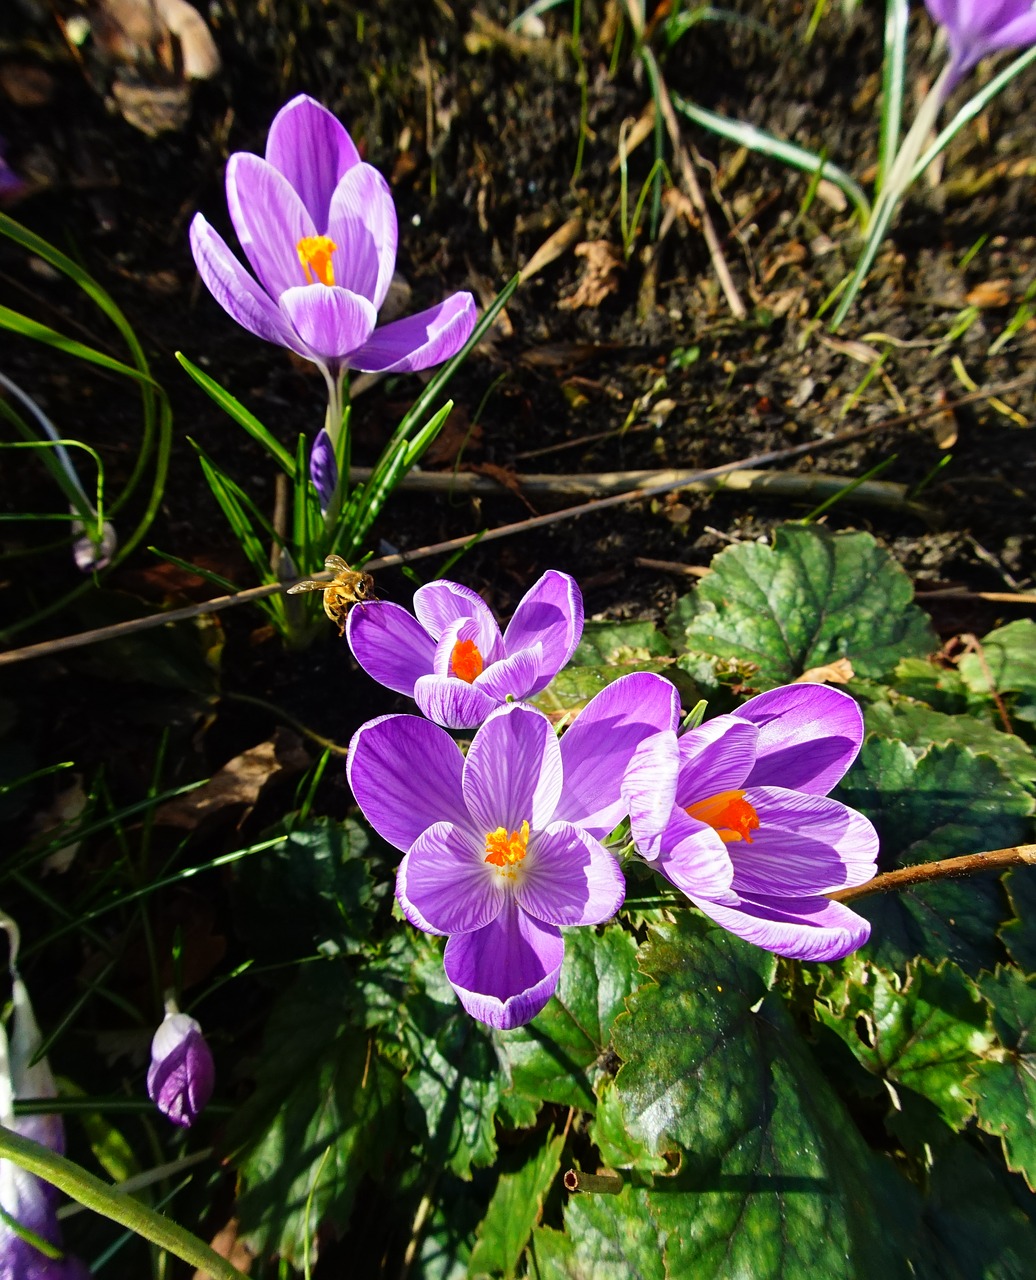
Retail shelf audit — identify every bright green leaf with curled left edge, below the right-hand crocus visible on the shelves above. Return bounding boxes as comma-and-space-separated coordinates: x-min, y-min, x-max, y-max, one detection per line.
817, 954, 992, 1129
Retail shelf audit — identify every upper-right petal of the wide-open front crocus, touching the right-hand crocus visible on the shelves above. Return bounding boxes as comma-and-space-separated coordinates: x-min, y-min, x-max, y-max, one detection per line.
554, 671, 680, 838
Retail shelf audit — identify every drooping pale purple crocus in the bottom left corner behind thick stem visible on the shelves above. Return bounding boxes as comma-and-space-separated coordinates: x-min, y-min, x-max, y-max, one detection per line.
0, 972, 90, 1280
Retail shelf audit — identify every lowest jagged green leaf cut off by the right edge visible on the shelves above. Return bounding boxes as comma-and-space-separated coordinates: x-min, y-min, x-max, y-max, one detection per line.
977, 969, 1036, 1190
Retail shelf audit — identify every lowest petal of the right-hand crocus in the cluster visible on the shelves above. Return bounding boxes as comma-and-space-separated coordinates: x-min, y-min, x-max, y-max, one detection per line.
694, 896, 871, 960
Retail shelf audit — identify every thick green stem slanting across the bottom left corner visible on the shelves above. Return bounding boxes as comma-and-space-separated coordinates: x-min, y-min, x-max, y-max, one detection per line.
0, 1125, 247, 1280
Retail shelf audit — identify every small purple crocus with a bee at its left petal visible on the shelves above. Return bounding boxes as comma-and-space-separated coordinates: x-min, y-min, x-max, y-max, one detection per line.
348, 570, 583, 728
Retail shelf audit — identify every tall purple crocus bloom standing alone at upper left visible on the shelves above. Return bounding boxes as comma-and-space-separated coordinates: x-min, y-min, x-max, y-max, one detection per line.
191, 95, 475, 379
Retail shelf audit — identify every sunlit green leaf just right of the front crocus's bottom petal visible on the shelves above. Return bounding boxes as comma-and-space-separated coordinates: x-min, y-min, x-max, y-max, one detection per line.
497, 924, 636, 1111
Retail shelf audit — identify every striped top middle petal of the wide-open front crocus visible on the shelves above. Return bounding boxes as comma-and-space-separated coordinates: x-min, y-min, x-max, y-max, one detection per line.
455, 703, 561, 835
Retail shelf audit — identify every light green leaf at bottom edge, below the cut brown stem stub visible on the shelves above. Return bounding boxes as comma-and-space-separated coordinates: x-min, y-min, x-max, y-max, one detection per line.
529, 1187, 660, 1280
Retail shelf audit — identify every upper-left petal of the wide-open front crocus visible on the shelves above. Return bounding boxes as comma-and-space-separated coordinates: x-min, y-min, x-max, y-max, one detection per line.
346, 716, 471, 851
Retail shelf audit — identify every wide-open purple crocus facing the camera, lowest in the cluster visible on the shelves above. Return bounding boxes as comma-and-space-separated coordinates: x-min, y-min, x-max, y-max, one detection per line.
347, 672, 679, 1029
